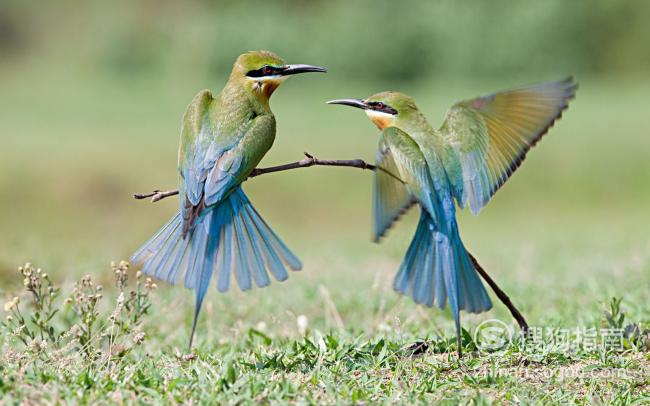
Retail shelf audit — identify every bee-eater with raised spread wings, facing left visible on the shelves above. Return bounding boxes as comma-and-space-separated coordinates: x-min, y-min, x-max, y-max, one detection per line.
328, 78, 576, 356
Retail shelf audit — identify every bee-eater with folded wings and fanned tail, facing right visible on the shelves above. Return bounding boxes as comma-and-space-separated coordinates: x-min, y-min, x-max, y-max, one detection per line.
131, 51, 326, 348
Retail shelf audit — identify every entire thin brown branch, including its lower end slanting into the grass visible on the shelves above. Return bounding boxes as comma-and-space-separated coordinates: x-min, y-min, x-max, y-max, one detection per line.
133, 152, 528, 334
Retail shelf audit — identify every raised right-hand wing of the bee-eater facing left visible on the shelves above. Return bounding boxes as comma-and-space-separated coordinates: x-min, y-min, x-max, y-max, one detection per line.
438, 78, 577, 214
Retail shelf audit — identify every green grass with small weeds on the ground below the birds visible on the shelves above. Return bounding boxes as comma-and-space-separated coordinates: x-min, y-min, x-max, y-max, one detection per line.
0, 263, 650, 404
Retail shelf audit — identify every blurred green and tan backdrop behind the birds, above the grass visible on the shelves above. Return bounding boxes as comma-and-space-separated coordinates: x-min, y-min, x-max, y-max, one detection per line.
0, 0, 650, 318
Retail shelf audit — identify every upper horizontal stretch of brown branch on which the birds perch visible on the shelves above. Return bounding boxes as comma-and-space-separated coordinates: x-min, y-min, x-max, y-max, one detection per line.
133, 152, 374, 202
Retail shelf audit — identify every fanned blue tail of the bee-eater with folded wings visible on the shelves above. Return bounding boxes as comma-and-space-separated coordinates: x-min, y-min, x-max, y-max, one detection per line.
131, 188, 302, 346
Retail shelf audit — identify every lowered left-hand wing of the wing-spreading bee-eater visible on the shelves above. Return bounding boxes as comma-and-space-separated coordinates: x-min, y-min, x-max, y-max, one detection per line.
373, 127, 435, 241
